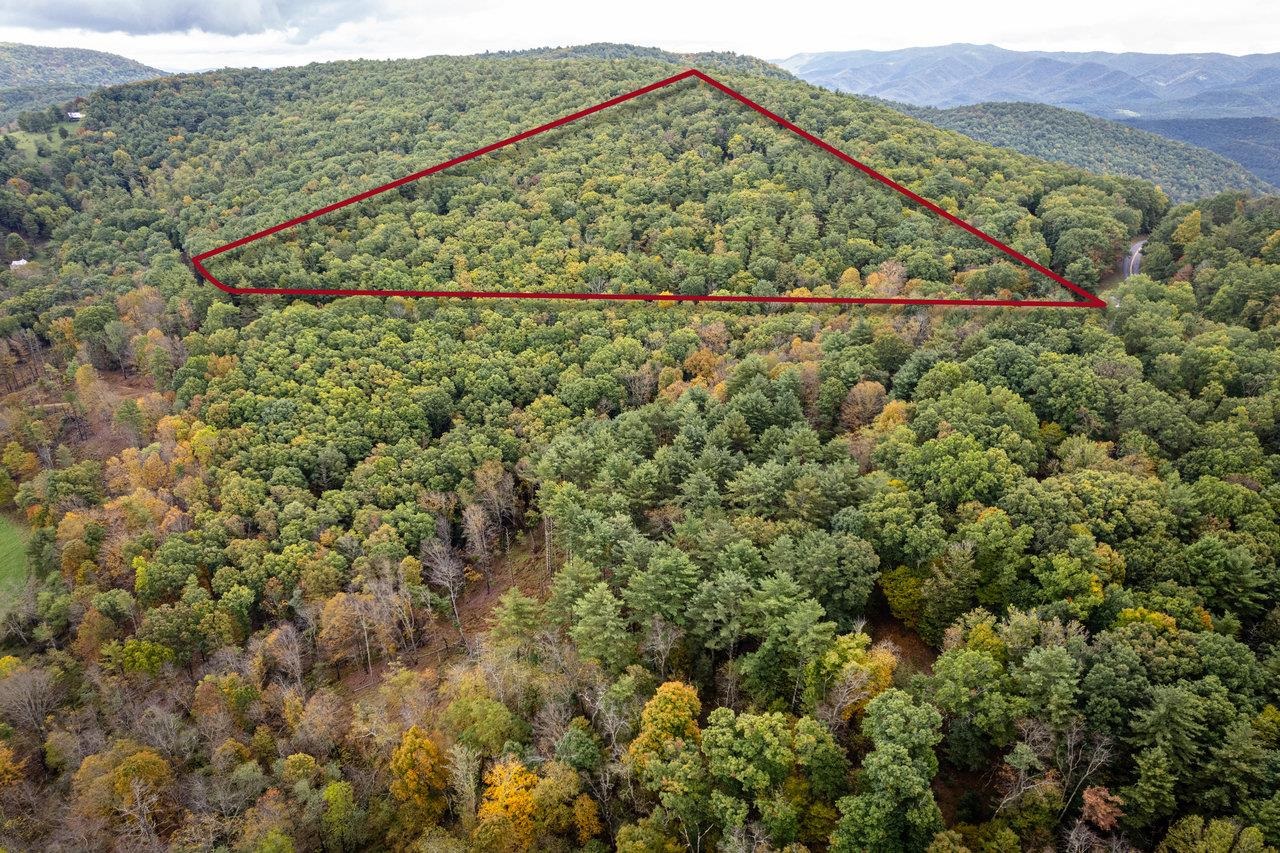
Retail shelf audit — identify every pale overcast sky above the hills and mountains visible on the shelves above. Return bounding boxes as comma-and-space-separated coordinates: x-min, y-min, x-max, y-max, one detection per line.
0, 0, 1280, 70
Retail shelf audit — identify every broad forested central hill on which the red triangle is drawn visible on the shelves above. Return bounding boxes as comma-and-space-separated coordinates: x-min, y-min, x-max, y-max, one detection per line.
77, 52, 1165, 298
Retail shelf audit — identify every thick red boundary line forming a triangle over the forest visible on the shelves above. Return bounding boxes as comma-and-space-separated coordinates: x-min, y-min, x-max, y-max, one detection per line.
191, 68, 1106, 309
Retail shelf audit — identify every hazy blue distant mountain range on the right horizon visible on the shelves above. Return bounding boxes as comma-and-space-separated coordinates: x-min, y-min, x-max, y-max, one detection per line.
778, 45, 1280, 118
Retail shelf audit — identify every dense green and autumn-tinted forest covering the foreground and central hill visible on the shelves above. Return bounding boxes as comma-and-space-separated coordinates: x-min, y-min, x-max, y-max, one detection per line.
0, 45, 1280, 853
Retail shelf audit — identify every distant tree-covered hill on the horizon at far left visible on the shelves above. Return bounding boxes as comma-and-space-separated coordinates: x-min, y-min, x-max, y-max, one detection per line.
0, 42, 165, 124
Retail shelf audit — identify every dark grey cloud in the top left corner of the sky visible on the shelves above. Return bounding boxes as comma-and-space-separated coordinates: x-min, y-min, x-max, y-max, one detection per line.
0, 0, 379, 37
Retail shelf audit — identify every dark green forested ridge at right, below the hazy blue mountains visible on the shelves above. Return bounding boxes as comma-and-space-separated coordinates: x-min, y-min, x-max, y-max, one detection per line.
892, 102, 1276, 201
